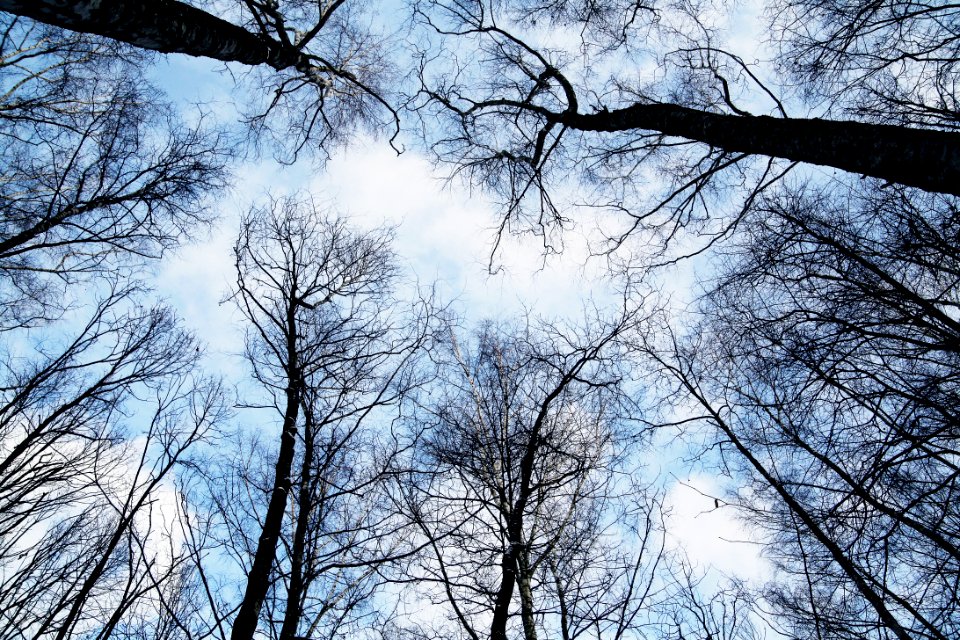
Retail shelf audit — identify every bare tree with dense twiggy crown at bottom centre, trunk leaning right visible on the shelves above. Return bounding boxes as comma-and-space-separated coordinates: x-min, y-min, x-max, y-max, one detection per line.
403, 317, 656, 640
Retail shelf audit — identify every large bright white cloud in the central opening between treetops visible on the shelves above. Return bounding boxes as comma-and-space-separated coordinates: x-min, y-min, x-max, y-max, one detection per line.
310, 141, 607, 319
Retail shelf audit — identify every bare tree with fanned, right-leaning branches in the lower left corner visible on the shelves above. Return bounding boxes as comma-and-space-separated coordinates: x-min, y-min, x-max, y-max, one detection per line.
0, 290, 222, 639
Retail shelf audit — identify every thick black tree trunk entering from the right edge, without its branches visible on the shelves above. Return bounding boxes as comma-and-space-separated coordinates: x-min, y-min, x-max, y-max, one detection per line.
556, 104, 960, 195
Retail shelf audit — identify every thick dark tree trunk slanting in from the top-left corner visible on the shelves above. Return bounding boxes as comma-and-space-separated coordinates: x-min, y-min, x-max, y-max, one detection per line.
0, 0, 300, 69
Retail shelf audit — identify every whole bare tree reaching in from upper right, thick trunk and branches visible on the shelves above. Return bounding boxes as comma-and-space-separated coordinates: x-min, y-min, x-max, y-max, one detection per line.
413, 0, 960, 254
